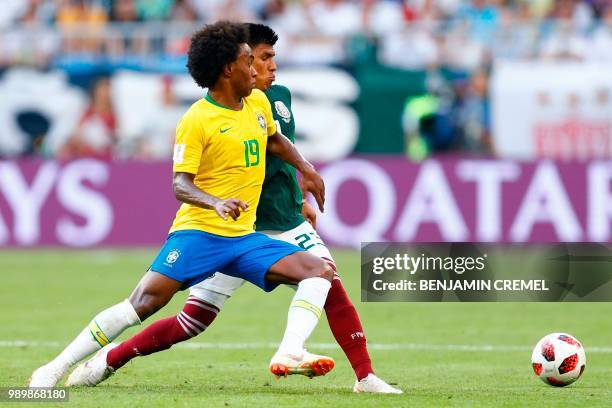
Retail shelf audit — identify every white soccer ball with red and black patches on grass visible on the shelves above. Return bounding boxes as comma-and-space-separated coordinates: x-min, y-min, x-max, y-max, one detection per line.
531, 333, 586, 387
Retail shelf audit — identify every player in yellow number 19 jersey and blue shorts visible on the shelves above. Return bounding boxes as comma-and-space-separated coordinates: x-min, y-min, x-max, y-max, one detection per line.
30, 22, 334, 387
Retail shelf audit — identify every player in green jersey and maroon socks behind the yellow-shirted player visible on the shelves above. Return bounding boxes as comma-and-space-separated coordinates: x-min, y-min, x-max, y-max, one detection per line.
37, 24, 402, 394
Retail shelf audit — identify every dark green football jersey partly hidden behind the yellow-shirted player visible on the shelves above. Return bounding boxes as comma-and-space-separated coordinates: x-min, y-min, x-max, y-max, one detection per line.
255, 85, 304, 231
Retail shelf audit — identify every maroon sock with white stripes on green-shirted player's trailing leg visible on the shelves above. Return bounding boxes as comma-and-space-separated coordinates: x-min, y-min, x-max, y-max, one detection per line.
106, 296, 219, 370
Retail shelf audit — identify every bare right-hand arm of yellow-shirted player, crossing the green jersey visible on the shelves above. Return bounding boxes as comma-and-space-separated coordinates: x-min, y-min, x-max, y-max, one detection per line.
266, 132, 325, 212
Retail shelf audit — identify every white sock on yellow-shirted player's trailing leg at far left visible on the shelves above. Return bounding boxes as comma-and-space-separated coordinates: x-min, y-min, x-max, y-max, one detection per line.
49, 299, 140, 372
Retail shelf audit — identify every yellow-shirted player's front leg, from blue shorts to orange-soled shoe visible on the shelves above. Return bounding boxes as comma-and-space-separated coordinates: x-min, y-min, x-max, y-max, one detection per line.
224, 234, 334, 375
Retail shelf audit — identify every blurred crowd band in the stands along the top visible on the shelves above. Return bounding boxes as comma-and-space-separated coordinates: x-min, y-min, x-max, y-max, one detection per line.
0, 0, 612, 69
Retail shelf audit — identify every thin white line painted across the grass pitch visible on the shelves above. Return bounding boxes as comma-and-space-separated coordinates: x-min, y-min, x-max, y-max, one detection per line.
0, 340, 612, 353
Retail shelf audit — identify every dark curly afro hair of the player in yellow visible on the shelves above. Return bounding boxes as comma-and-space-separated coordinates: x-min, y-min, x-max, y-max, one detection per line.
187, 21, 249, 88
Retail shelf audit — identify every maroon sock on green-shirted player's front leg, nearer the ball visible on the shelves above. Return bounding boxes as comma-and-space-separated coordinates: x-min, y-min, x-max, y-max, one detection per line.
325, 277, 374, 380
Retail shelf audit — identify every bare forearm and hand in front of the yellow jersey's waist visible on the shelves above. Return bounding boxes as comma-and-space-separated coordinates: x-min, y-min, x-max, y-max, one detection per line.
172, 172, 249, 221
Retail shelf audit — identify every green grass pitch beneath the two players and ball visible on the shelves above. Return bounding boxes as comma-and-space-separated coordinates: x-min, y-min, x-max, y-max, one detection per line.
0, 249, 612, 407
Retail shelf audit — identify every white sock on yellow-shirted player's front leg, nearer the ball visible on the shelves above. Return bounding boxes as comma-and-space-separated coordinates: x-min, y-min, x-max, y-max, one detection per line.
277, 278, 331, 356
